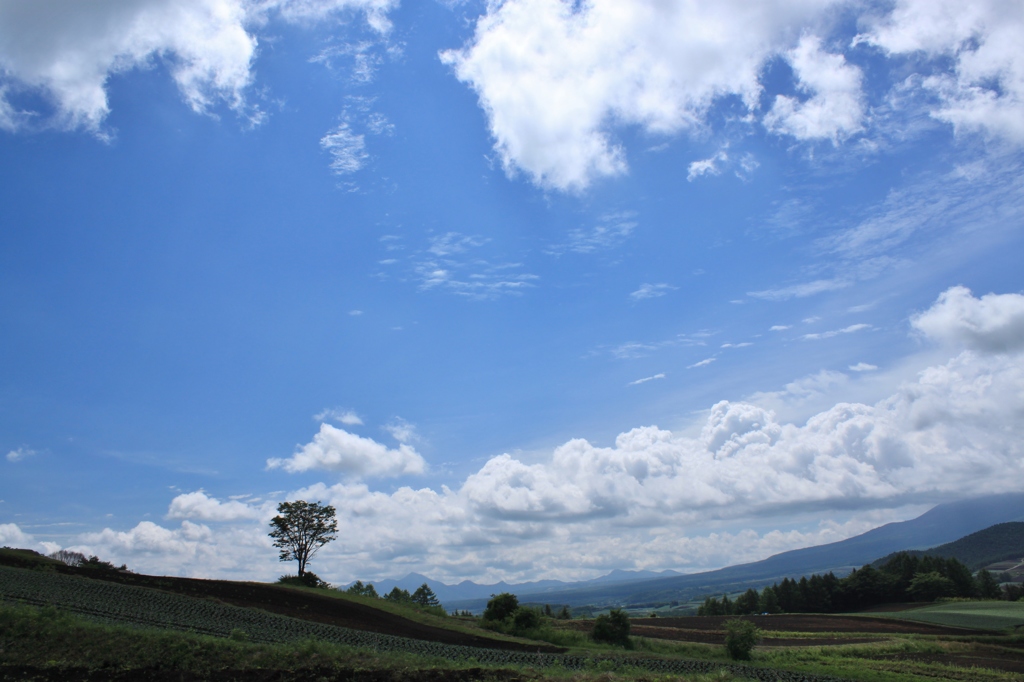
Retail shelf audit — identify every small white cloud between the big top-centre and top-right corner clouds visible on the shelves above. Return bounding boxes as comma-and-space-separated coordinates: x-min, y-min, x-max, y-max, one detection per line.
764, 35, 864, 143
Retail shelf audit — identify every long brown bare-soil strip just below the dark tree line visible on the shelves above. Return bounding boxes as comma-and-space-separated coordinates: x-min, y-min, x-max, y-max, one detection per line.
633, 613, 991, 636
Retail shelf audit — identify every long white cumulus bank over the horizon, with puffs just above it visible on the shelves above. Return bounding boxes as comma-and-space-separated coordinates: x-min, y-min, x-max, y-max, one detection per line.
68, 288, 1024, 580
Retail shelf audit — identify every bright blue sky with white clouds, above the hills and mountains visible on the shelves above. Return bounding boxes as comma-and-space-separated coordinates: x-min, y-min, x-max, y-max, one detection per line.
0, 0, 1024, 582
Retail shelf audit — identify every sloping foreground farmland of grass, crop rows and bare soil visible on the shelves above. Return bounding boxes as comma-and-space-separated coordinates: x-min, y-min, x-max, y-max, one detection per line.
0, 549, 1024, 682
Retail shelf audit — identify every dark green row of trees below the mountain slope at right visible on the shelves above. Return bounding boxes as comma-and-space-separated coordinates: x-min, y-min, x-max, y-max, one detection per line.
697, 552, 1022, 615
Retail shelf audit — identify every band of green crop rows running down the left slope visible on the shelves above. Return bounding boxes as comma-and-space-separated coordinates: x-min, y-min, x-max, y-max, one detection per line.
0, 566, 835, 682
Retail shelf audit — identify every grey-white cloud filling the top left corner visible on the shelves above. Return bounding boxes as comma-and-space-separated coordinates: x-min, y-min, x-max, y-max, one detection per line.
0, 0, 397, 134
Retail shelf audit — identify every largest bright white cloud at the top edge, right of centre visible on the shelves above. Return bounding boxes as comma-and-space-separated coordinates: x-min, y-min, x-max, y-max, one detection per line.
441, 0, 835, 189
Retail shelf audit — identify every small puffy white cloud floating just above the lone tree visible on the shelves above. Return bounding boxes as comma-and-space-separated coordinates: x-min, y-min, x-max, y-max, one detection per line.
266, 424, 426, 478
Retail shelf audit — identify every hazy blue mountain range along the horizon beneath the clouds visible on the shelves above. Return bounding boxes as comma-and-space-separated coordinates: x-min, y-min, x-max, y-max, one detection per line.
360, 494, 1024, 611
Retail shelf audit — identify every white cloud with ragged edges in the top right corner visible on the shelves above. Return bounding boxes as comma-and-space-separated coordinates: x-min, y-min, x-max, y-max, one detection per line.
859, 0, 1024, 143
